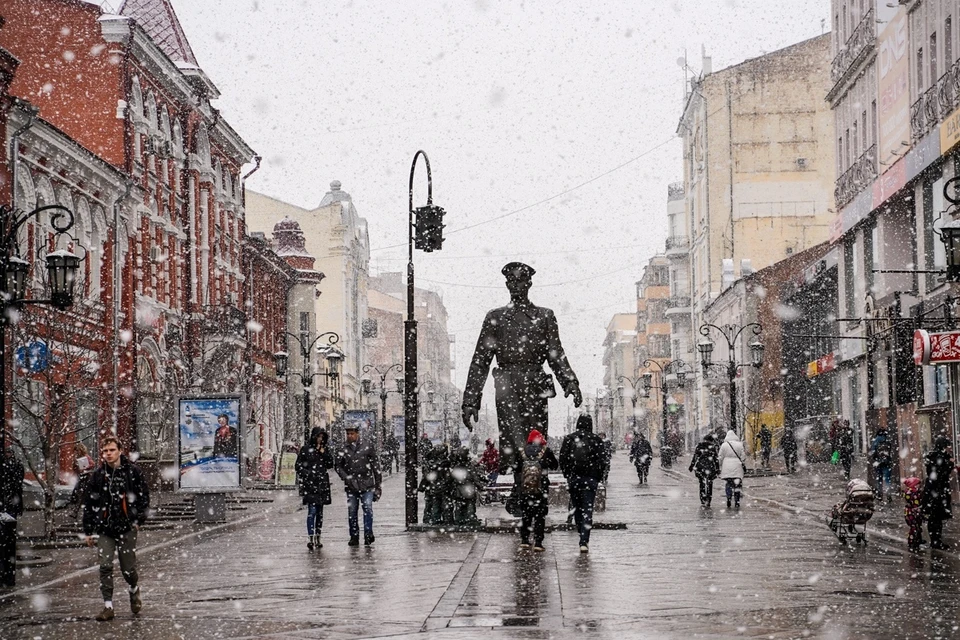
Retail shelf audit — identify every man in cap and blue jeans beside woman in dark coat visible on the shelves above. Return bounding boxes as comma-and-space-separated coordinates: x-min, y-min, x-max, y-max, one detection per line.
336, 425, 383, 547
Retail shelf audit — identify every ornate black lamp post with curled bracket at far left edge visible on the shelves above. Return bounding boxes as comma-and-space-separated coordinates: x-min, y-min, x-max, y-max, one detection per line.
0, 204, 80, 455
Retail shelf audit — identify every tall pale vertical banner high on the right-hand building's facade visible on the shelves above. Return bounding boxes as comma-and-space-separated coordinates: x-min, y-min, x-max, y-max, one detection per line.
877, 6, 910, 167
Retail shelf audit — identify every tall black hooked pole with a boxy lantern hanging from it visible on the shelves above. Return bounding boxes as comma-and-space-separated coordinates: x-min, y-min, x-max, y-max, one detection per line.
403, 150, 444, 525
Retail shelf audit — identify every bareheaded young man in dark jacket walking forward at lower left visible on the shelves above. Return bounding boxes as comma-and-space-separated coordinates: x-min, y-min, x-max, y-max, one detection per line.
83, 436, 150, 622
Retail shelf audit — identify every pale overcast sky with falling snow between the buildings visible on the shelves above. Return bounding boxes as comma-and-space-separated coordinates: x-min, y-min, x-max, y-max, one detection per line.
167, 0, 830, 420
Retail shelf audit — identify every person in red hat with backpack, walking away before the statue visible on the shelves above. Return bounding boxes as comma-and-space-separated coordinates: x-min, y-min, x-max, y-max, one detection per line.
514, 429, 560, 551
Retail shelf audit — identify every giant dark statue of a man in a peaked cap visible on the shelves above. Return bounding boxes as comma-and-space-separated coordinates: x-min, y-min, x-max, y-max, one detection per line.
462, 262, 583, 473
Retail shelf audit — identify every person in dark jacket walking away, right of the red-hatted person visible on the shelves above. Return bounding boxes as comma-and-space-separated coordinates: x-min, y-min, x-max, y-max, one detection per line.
560, 415, 609, 553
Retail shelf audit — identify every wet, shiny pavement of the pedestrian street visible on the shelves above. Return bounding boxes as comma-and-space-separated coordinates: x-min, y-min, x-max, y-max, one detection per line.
0, 452, 960, 640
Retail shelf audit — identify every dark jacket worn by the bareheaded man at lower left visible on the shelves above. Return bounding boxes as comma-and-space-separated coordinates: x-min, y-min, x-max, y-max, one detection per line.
83, 455, 150, 538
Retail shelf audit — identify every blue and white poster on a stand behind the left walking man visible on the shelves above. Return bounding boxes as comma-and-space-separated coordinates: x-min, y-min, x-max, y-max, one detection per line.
177, 395, 242, 493
